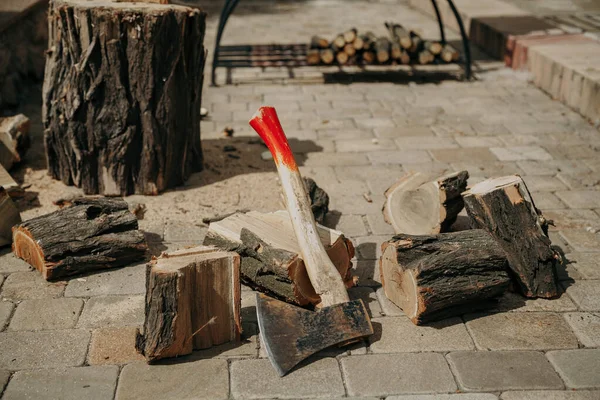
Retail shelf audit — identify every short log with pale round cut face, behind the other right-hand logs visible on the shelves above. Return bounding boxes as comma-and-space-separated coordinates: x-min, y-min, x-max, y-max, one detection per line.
383, 171, 469, 235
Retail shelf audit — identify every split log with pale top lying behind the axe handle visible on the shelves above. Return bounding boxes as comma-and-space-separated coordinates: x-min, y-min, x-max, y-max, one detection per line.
204, 211, 356, 306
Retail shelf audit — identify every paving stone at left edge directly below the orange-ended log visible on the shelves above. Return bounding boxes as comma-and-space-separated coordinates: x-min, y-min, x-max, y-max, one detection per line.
1, 271, 65, 301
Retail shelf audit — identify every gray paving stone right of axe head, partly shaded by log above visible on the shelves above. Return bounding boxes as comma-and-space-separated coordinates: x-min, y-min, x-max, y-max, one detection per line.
369, 316, 475, 353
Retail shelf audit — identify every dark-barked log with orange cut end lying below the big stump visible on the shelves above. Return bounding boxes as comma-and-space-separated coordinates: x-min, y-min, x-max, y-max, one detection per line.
13, 198, 148, 280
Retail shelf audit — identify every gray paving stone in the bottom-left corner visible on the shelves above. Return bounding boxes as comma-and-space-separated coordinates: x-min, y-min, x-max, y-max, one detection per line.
3, 366, 119, 400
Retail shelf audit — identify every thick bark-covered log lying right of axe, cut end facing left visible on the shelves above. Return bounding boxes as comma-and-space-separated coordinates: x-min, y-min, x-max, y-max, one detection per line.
380, 229, 510, 325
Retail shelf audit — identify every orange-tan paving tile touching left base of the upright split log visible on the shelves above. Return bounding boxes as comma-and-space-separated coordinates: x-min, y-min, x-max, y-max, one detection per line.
88, 327, 144, 365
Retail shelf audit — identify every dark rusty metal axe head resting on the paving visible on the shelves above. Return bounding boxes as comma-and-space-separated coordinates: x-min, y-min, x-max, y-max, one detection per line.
256, 293, 373, 376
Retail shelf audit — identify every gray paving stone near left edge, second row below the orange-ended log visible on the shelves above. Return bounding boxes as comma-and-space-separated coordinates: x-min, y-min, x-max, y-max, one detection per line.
8, 298, 83, 331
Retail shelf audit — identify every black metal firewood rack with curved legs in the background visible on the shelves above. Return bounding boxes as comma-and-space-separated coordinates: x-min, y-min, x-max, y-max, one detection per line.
211, 0, 471, 86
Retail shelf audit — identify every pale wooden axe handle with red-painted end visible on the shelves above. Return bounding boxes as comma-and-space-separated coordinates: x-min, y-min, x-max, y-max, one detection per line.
250, 107, 350, 307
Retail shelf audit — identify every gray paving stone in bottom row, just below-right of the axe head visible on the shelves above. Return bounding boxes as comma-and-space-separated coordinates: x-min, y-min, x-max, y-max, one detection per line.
341, 354, 456, 396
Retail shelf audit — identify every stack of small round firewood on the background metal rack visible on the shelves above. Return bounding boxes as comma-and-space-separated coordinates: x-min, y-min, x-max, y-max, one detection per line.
306, 22, 460, 65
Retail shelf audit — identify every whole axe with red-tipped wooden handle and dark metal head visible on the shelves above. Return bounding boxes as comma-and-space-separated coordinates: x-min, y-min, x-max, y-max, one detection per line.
250, 107, 373, 376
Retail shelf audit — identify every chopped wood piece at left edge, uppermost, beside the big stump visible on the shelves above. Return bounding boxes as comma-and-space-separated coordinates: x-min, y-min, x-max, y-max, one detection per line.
0, 114, 30, 170
